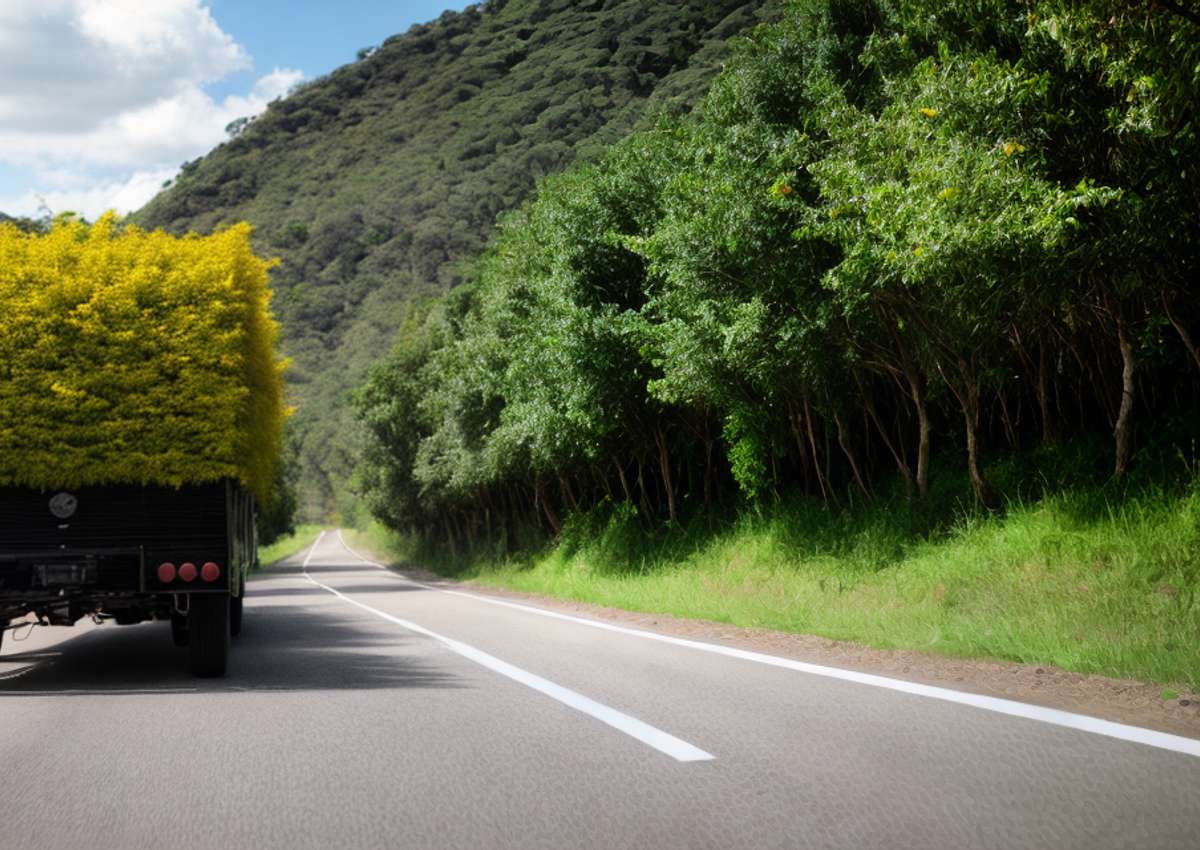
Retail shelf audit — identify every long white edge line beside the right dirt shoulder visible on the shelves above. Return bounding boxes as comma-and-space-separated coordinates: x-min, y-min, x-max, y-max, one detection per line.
337, 529, 1200, 758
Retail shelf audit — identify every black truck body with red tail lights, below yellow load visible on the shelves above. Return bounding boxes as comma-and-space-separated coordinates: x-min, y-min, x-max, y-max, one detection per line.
0, 481, 257, 677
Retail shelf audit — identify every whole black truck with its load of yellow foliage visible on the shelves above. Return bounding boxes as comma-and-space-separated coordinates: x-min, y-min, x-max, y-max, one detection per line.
0, 216, 287, 677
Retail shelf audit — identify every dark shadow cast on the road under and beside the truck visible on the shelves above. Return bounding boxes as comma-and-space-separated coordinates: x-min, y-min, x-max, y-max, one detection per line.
0, 597, 462, 699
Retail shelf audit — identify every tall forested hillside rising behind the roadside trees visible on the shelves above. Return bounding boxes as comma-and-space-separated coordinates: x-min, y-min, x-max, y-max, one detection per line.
133, 0, 762, 513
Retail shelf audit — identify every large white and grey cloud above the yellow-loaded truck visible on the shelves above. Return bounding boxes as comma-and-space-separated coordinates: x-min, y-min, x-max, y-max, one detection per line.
0, 0, 304, 215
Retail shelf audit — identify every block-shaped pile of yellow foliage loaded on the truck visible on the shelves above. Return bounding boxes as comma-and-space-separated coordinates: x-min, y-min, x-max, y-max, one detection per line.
0, 215, 286, 498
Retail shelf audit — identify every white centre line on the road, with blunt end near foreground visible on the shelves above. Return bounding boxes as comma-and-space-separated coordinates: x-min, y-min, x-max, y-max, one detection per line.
302, 532, 715, 761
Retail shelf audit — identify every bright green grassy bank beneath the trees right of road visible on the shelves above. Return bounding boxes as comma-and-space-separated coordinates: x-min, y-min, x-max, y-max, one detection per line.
350, 465, 1200, 693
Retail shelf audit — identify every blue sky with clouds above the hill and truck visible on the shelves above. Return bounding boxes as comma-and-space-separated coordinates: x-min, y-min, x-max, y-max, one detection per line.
0, 0, 468, 219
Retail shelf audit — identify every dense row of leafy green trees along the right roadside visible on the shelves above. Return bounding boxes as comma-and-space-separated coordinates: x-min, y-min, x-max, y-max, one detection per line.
359, 0, 1200, 552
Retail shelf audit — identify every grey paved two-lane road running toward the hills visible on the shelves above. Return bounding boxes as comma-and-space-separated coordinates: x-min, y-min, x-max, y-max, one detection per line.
0, 534, 1200, 850
